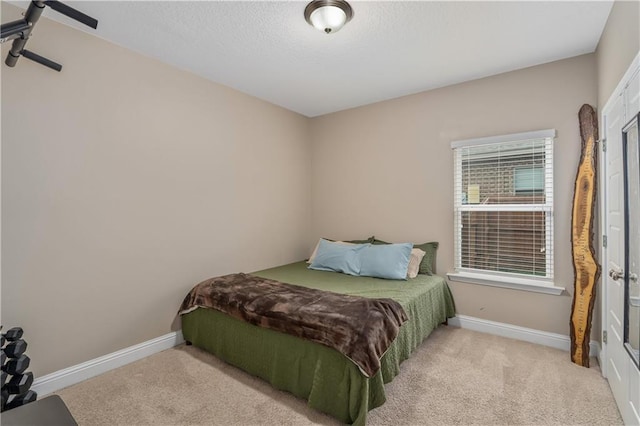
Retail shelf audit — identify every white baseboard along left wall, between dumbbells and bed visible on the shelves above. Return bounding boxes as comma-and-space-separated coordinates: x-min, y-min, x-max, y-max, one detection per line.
31, 330, 184, 397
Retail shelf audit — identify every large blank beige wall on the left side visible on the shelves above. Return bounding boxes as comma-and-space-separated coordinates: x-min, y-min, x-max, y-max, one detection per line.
1, 3, 311, 376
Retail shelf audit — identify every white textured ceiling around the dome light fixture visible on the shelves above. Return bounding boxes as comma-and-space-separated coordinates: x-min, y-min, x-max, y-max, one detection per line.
6, 1, 612, 117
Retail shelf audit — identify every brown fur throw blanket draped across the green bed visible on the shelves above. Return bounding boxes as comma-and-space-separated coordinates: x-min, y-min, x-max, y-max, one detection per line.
180, 274, 407, 377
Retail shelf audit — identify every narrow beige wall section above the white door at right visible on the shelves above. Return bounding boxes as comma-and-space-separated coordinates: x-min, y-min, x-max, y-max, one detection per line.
596, 0, 640, 110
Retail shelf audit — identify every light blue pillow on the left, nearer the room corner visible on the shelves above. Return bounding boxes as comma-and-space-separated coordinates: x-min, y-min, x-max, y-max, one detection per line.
309, 239, 371, 275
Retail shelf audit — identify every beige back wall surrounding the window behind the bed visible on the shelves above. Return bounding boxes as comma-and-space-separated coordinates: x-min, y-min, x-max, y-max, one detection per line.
311, 54, 597, 335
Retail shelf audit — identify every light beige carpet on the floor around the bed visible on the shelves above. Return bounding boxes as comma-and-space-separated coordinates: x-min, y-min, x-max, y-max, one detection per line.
58, 327, 622, 425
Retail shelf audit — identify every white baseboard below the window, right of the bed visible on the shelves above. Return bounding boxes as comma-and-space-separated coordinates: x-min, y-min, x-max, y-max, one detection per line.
449, 315, 600, 361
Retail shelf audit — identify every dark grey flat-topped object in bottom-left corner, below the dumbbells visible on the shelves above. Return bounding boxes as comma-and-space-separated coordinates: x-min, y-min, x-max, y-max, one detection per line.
2, 395, 78, 426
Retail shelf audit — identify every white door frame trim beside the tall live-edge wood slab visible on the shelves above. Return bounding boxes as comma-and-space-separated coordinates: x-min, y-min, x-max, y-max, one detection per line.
598, 52, 640, 417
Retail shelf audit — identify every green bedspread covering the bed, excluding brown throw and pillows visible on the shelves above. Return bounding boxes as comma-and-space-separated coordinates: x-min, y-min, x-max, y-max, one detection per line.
182, 261, 455, 425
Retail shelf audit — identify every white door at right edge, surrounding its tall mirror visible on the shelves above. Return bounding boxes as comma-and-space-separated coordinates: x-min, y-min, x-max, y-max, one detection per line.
601, 65, 640, 425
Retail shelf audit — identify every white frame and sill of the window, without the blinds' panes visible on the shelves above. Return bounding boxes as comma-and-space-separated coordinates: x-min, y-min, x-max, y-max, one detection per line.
447, 129, 564, 295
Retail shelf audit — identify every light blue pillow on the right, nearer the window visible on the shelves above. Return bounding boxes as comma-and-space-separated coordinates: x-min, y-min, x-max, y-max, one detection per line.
360, 243, 413, 280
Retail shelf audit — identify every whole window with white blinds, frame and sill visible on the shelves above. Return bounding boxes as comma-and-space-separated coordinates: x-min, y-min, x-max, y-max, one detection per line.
450, 130, 562, 294
